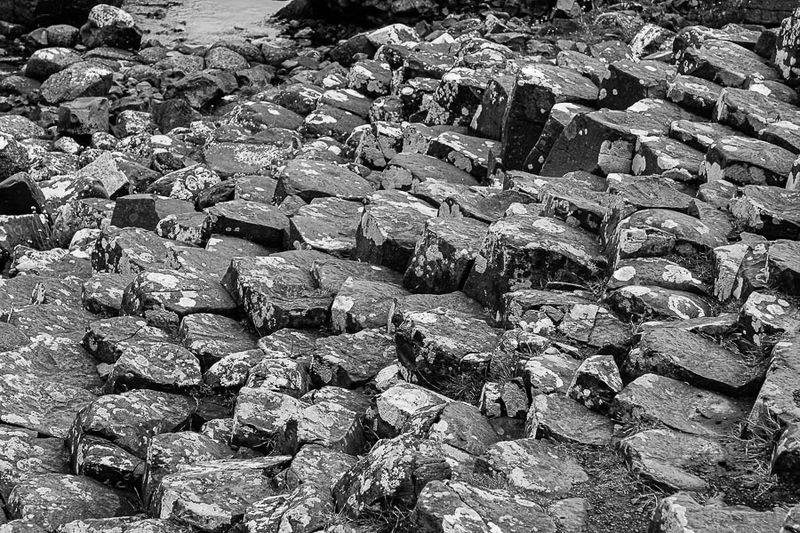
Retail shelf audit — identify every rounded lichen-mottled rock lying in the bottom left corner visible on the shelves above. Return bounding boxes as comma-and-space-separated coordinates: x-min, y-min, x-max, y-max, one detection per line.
8, 474, 135, 531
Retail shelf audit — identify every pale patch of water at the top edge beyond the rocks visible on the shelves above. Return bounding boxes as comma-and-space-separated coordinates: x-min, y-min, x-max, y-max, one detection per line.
123, 0, 287, 44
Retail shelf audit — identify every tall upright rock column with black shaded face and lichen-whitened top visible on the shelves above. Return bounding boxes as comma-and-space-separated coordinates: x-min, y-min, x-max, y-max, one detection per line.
502, 64, 597, 169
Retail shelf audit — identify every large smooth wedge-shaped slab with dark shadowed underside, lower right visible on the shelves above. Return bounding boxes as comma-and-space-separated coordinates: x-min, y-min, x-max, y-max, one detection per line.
624, 328, 763, 396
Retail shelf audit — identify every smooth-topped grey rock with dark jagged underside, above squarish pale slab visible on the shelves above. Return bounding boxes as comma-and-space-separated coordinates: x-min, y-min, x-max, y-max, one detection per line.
275, 159, 373, 203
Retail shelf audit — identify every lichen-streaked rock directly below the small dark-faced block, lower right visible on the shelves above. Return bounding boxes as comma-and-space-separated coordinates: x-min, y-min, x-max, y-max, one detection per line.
525, 394, 614, 446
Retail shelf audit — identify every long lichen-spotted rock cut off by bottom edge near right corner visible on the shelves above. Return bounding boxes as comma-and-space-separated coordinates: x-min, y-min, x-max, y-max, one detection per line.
650, 492, 784, 533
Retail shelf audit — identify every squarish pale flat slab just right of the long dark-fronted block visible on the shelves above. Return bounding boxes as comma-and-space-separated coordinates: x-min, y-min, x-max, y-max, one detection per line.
289, 198, 364, 257
